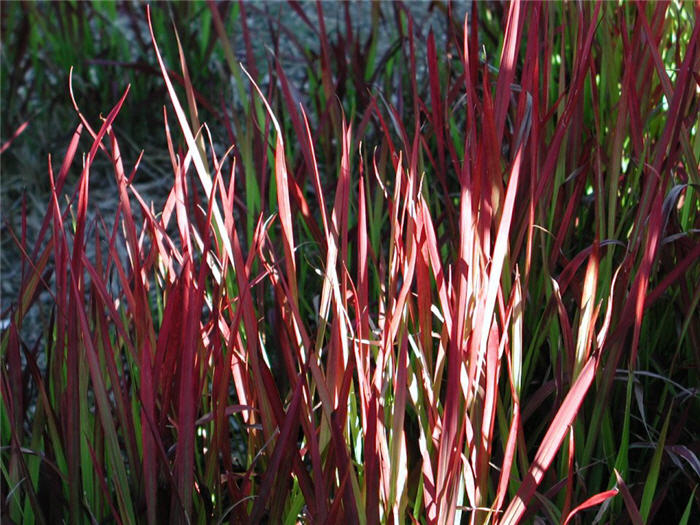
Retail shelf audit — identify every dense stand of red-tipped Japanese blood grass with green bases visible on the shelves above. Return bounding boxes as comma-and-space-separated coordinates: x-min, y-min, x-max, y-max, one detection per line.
1, 2, 700, 524
